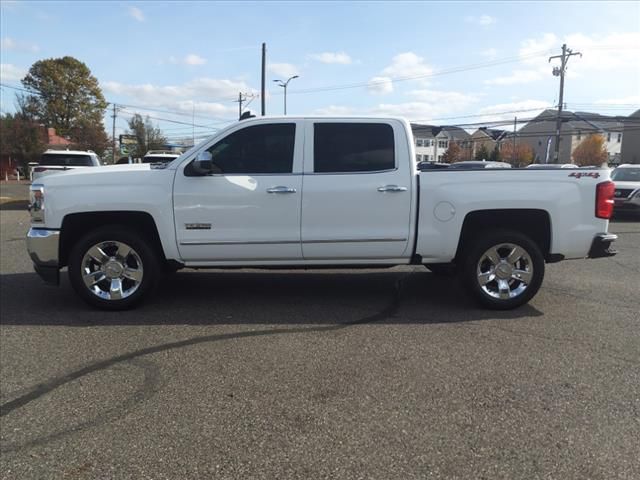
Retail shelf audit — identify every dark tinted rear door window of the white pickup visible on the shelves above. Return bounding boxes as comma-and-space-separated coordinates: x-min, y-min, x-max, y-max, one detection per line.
313, 123, 395, 173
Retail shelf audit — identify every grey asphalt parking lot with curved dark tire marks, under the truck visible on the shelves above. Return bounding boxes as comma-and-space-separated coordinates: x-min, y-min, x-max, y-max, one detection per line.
0, 189, 640, 479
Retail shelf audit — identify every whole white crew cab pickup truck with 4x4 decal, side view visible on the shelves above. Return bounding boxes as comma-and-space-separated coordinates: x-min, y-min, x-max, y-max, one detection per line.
27, 117, 616, 310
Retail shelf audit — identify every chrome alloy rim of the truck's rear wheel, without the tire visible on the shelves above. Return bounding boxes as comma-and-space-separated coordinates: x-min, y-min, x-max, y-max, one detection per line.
476, 243, 533, 300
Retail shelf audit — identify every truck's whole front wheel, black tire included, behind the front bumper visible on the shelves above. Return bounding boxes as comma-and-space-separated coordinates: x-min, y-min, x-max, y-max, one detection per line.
69, 225, 160, 310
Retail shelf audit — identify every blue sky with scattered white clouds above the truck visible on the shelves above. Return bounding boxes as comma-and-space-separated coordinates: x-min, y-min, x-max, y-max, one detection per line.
0, 0, 640, 140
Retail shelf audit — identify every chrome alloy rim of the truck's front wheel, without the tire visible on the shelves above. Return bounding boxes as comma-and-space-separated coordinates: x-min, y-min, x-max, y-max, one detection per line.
81, 241, 144, 300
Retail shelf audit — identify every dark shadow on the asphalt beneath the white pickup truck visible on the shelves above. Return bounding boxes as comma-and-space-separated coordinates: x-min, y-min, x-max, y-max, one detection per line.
0, 270, 543, 327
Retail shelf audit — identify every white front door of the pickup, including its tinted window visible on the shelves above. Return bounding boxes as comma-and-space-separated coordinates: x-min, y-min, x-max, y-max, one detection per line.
174, 121, 304, 265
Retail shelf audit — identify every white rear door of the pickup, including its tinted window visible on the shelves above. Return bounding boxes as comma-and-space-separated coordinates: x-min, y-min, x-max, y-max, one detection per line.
301, 120, 413, 262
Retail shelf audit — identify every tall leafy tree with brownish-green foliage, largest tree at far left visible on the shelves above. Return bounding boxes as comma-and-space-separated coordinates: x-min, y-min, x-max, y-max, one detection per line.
18, 57, 108, 154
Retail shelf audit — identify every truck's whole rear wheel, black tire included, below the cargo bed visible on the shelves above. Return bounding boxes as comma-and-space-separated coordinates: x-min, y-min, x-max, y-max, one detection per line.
462, 230, 545, 310
